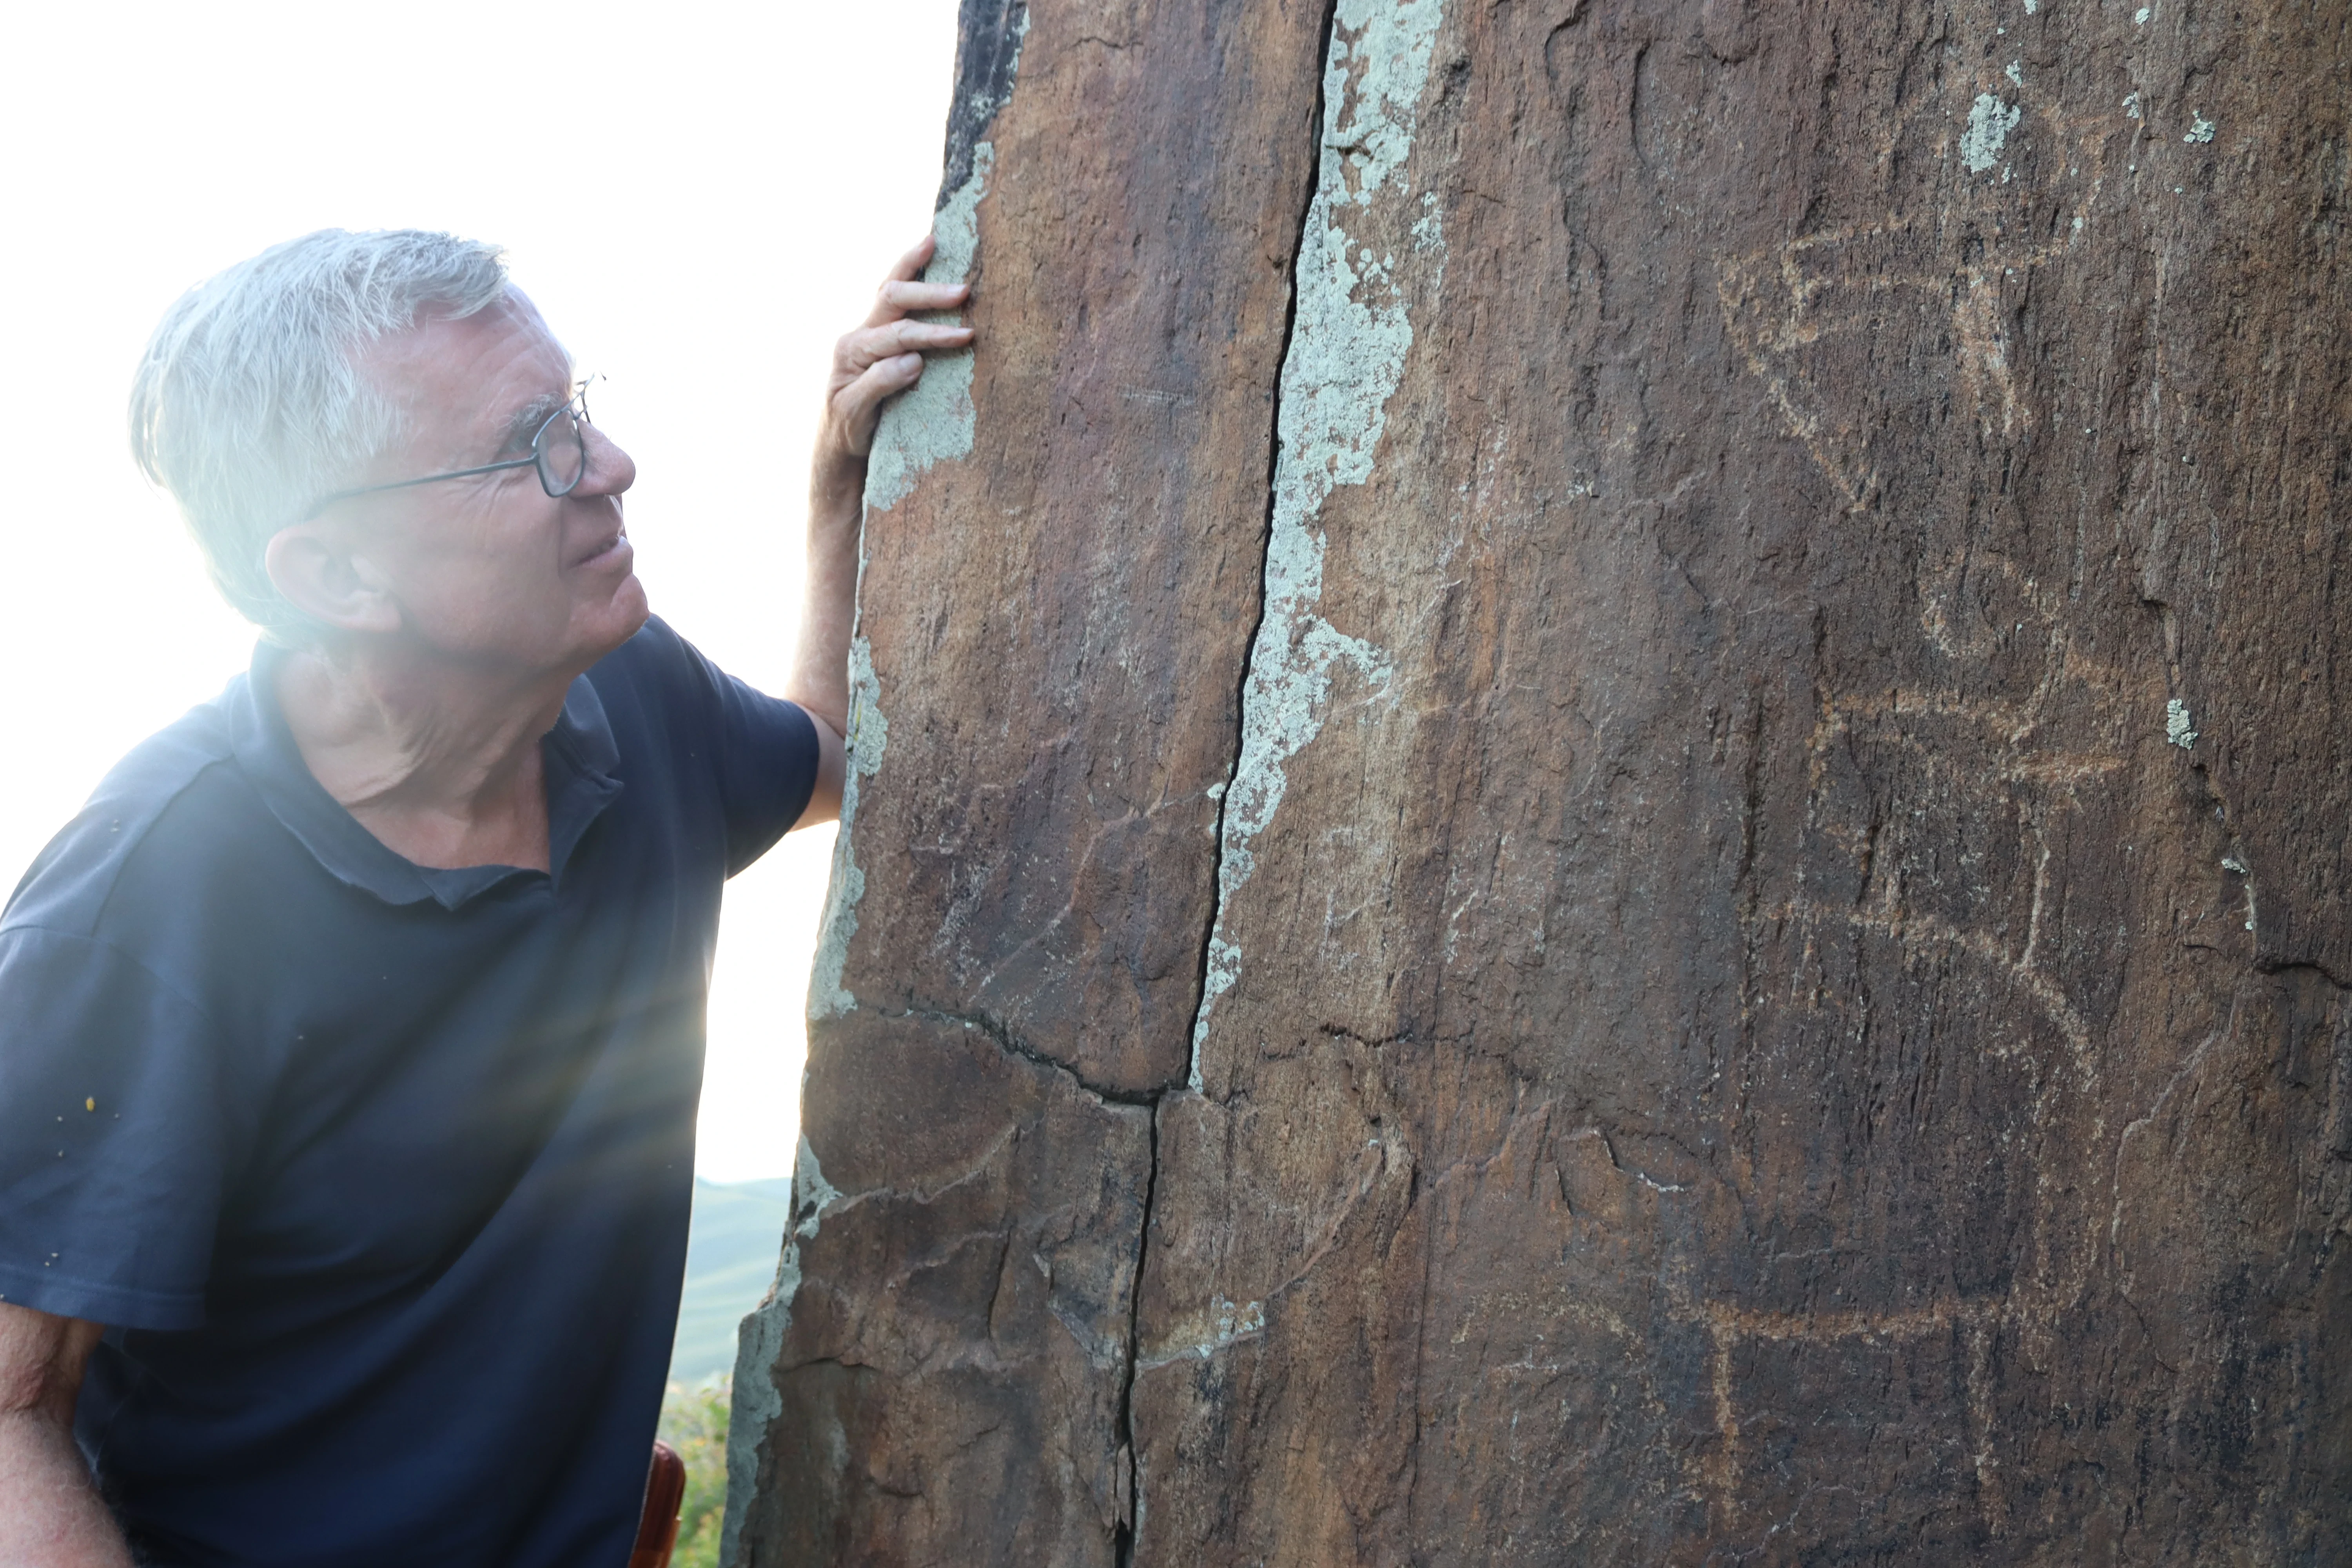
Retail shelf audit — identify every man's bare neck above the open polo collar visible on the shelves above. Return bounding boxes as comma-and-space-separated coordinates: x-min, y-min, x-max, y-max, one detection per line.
278, 646, 572, 870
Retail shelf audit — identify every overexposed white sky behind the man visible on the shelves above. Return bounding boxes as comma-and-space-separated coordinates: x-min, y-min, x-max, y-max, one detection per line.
0, 0, 955, 1180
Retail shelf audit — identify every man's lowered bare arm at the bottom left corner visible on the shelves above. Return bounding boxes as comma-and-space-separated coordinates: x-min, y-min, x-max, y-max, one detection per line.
0, 1302, 132, 1568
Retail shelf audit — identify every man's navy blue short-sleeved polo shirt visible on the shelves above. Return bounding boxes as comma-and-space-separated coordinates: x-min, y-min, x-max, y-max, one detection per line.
0, 621, 818, 1568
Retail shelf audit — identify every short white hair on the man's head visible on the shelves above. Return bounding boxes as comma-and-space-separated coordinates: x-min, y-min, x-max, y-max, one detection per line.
132, 228, 506, 642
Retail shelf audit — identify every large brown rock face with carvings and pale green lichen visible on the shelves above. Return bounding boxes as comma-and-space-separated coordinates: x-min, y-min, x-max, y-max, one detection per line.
729, 0, 2352, 1568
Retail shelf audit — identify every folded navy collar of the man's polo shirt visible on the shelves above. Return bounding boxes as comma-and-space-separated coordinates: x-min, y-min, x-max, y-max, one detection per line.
226, 642, 621, 910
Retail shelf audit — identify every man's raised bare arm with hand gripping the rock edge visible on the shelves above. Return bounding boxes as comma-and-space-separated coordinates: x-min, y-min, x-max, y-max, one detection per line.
783, 240, 971, 828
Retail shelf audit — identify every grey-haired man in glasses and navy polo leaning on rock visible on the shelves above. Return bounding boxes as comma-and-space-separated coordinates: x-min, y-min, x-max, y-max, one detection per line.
0, 230, 971, 1568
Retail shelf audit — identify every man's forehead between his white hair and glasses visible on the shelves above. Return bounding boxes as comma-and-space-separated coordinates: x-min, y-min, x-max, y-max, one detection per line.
358, 289, 572, 451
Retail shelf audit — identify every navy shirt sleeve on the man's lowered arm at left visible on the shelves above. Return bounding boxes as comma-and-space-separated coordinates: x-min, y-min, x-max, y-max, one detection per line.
0, 926, 235, 1328
